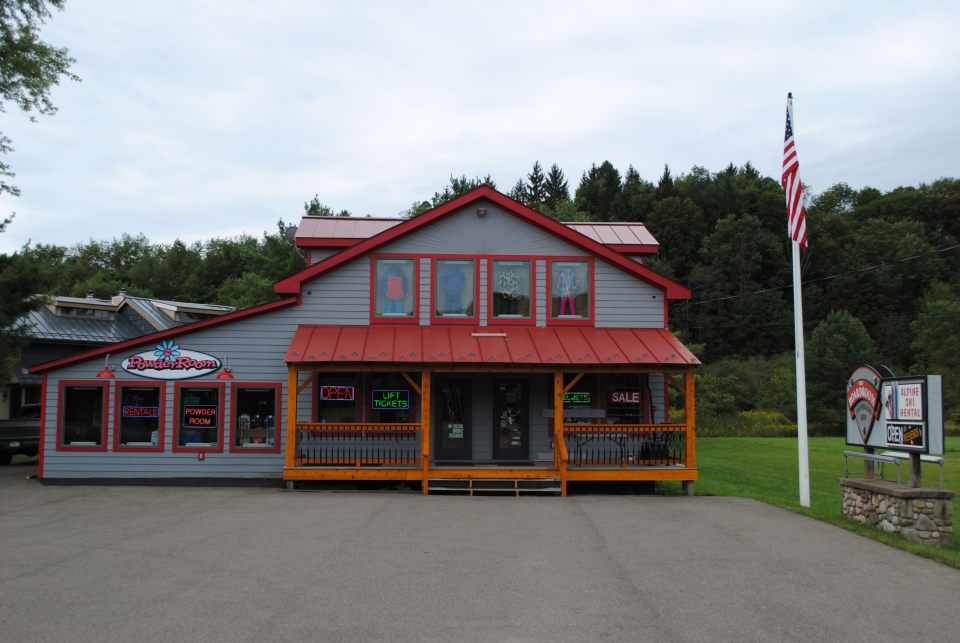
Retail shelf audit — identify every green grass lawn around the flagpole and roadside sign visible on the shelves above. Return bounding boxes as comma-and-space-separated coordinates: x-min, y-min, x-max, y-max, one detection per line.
696, 437, 960, 569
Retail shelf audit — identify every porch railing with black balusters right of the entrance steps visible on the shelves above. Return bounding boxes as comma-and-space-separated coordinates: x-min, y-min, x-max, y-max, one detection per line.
563, 424, 687, 467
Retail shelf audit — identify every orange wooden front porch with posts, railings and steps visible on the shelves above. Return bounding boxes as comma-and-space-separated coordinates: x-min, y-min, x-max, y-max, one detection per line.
284, 364, 698, 496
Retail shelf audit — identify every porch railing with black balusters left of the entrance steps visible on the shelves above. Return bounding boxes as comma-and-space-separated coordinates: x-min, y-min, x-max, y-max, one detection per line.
294, 422, 421, 467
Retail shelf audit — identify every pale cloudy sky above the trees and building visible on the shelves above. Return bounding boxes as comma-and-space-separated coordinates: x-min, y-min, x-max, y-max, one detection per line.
0, 0, 960, 252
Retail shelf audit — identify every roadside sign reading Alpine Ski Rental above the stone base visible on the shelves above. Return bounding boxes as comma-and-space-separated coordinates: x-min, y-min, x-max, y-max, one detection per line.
846, 366, 943, 455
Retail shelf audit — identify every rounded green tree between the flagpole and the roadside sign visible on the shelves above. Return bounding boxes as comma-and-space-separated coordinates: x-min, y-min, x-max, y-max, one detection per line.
805, 310, 880, 425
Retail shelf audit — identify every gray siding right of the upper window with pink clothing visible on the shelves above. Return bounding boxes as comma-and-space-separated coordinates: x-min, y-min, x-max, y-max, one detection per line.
593, 261, 663, 328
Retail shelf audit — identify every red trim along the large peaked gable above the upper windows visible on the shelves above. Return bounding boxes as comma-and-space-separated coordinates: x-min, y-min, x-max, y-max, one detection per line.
273, 185, 690, 299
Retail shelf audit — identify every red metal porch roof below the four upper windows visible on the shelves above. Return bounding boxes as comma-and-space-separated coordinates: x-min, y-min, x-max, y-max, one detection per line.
284, 325, 700, 366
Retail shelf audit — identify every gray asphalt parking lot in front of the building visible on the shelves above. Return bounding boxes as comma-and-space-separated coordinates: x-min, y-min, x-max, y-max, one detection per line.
0, 464, 960, 643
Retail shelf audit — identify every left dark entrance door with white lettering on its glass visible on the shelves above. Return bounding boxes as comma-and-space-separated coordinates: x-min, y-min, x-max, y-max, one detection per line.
433, 377, 473, 462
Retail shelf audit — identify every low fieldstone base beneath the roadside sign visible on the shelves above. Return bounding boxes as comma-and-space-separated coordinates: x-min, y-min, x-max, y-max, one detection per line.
837, 478, 956, 549
